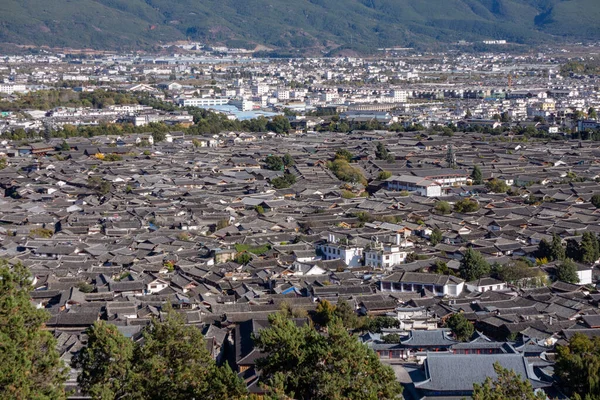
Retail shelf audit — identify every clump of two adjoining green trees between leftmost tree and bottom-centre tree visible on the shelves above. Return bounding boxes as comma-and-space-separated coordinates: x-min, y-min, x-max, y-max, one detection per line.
72, 307, 246, 400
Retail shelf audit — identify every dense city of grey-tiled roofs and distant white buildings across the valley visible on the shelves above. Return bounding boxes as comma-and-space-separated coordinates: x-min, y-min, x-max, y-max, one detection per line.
0, 45, 600, 399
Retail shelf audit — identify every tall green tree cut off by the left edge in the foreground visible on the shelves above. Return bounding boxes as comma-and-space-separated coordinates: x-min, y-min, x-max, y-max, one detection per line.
0, 260, 67, 400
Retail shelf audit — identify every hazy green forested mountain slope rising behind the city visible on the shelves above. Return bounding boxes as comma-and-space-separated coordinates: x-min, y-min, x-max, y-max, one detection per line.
0, 0, 600, 50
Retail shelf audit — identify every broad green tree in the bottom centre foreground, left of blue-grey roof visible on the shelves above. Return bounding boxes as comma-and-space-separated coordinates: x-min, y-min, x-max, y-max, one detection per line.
254, 314, 402, 400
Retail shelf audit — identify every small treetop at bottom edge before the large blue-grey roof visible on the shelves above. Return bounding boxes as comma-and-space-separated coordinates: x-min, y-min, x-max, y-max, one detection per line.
473, 363, 546, 400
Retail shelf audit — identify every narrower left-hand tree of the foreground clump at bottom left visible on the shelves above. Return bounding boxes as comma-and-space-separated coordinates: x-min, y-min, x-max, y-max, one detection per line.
72, 321, 134, 400
